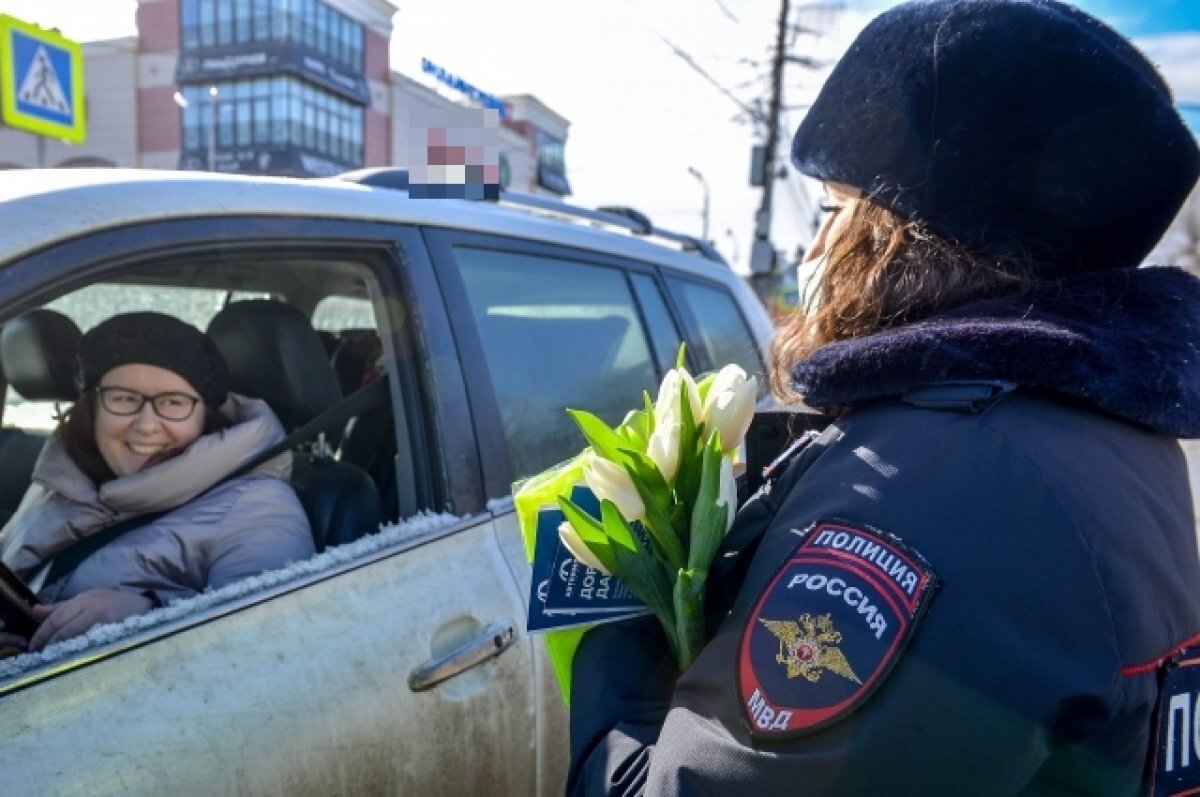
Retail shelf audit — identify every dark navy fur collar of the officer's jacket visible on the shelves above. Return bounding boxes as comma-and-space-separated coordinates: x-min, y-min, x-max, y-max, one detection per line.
792, 268, 1200, 437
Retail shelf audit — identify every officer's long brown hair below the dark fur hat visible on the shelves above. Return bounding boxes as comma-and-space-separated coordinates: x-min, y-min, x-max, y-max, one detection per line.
770, 193, 1034, 402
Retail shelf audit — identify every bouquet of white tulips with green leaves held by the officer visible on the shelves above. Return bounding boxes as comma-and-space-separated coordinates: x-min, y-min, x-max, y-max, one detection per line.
515, 348, 757, 669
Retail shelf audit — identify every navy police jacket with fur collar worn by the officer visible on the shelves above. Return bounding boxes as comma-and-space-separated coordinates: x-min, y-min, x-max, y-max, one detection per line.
568, 269, 1200, 797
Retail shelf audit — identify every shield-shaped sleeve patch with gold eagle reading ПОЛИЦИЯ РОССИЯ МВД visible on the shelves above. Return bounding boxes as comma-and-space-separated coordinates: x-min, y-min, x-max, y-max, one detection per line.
738, 521, 937, 738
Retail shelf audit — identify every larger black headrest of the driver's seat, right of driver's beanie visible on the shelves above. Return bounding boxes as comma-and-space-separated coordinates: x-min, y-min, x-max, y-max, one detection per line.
208, 299, 342, 432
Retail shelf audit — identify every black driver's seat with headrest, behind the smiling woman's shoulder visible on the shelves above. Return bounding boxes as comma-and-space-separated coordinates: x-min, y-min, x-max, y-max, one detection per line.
208, 299, 383, 551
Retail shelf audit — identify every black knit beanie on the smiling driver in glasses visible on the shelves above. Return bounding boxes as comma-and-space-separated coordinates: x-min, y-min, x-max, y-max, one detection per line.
76, 312, 229, 408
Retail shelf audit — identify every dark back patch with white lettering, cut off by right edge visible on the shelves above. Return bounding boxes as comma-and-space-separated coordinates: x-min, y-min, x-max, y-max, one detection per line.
1151, 647, 1200, 797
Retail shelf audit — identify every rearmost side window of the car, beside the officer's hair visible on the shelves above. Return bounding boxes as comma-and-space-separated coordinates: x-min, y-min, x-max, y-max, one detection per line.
667, 278, 763, 384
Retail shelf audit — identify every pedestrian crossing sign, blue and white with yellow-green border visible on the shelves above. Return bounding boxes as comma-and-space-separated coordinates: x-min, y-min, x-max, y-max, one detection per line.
0, 14, 88, 144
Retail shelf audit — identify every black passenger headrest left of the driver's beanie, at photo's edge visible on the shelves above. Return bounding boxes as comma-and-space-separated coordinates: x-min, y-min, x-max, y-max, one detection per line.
0, 308, 83, 401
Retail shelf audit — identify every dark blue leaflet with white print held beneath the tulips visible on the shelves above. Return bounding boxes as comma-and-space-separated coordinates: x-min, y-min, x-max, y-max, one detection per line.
526, 486, 648, 633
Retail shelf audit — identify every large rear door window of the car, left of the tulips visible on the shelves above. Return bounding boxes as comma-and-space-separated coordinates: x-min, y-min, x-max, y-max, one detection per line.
455, 246, 658, 479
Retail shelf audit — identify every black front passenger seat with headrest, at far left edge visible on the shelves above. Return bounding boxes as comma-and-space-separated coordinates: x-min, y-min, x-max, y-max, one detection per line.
0, 308, 83, 522
